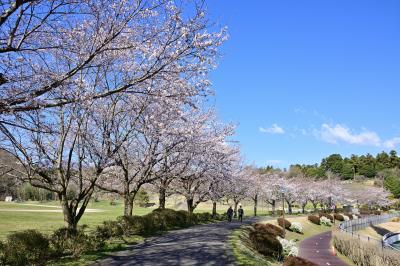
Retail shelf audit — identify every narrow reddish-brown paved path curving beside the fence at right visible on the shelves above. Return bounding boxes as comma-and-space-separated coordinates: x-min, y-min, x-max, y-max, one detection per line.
299, 231, 347, 266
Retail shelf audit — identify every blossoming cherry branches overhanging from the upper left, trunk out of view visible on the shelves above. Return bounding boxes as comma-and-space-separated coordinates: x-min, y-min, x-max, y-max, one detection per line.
0, 0, 226, 114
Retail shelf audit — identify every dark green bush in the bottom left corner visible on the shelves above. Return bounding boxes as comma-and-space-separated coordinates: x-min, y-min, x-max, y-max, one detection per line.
2, 230, 51, 265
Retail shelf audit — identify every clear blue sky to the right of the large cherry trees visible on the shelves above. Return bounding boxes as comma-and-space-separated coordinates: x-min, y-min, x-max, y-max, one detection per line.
207, 0, 400, 167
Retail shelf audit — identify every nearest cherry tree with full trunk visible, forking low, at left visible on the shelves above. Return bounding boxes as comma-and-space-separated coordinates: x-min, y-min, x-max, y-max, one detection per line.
2, 98, 128, 229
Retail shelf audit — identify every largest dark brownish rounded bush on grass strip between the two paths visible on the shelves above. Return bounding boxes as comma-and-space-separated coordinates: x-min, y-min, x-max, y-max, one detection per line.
249, 229, 283, 258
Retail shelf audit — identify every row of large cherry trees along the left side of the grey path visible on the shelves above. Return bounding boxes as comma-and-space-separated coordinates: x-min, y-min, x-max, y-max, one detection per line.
0, 0, 240, 228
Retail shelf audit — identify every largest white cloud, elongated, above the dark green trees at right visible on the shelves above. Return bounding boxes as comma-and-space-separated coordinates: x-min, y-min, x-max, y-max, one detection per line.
314, 124, 381, 146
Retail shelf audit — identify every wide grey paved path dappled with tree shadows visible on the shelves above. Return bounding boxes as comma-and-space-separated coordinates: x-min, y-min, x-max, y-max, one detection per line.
95, 219, 256, 266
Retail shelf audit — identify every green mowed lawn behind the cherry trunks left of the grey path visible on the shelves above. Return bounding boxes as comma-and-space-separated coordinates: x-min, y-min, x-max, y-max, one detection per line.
0, 198, 276, 240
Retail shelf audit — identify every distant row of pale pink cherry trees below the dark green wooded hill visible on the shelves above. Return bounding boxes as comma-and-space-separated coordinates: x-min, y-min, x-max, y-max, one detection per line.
238, 167, 393, 215
